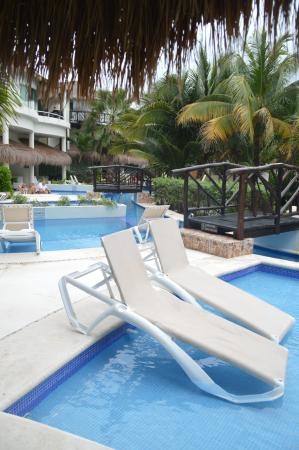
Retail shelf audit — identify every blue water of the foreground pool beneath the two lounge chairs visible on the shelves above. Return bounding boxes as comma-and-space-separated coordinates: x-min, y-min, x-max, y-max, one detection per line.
27, 267, 299, 450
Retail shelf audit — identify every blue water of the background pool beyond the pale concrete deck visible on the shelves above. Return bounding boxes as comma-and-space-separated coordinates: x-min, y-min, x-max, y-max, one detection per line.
0, 195, 143, 253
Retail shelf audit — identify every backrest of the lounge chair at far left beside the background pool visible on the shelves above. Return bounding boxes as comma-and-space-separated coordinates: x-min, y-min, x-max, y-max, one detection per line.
2, 205, 33, 231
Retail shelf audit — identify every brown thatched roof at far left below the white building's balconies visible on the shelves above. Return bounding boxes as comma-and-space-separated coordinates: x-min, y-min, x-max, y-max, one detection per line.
0, 142, 72, 167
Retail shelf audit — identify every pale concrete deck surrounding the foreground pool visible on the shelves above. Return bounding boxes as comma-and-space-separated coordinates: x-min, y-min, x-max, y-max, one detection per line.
0, 248, 299, 450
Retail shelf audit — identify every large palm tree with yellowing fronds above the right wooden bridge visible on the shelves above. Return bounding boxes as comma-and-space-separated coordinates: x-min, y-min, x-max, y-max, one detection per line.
178, 31, 299, 165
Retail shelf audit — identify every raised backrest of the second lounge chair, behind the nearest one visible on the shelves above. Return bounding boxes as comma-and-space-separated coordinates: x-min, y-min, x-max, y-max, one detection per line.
150, 219, 188, 274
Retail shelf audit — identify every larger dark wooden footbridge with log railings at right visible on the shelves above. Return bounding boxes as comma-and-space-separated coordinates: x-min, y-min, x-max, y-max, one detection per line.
173, 162, 299, 239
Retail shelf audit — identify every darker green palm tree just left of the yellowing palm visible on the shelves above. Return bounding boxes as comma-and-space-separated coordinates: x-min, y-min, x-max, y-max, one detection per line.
109, 47, 232, 173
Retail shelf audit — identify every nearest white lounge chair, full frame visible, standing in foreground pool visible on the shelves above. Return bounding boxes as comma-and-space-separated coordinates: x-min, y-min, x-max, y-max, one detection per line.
59, 230, 288, 403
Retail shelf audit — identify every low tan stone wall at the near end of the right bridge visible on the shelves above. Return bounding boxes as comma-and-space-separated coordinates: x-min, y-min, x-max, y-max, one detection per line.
181, 228, 253, 258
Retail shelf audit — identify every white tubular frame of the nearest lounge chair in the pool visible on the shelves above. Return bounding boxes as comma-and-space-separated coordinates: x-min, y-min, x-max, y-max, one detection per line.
59, 263, 284, 404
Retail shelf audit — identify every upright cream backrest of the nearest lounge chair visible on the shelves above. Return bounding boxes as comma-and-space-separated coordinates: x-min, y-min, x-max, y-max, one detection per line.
102, 230, 153, 307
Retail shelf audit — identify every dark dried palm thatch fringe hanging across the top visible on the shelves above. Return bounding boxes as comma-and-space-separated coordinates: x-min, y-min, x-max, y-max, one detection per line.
0, 0, 299, 96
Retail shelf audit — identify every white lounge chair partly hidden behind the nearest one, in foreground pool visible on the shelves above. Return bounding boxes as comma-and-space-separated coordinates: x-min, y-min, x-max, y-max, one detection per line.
150, 219, 295, 342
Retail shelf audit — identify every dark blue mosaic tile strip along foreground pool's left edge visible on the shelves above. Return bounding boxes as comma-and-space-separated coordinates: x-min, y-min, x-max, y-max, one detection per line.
5, 325, 129, 416
